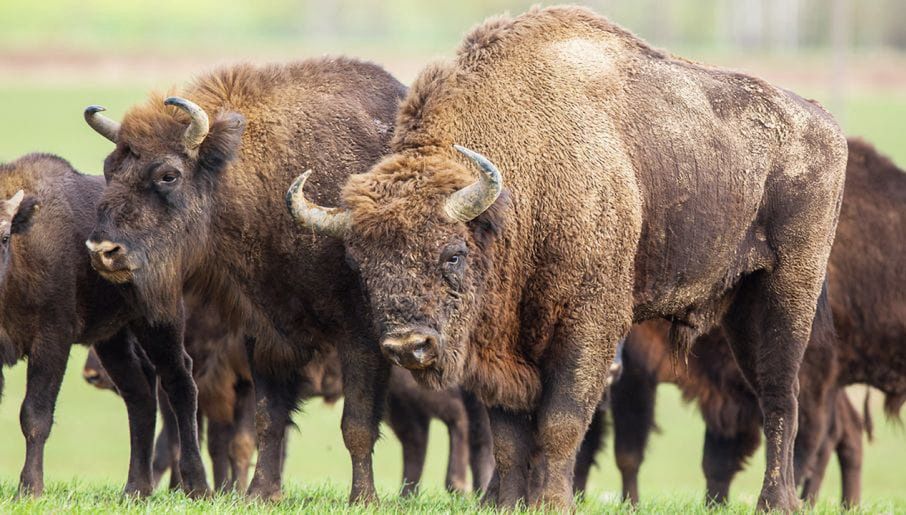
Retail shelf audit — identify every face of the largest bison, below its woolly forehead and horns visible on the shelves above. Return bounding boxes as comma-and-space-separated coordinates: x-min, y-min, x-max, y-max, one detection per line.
346, 224, 485, 388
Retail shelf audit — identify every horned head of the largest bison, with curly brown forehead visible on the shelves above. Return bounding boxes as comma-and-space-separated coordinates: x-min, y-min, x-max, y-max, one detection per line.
287, 146, 503, 388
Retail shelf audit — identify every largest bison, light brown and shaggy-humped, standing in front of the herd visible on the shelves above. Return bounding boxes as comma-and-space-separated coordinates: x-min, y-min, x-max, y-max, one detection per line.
289, 7, 846, 509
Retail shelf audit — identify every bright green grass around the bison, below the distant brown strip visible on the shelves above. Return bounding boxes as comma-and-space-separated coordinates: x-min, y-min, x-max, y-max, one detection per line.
0, 82, 906, 513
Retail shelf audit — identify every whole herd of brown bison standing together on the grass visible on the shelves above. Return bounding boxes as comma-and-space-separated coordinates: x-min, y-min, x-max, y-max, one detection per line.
0, 7, 906, 510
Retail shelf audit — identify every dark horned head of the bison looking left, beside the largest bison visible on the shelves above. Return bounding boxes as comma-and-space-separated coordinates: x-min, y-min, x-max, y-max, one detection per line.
85, 97, 245, 318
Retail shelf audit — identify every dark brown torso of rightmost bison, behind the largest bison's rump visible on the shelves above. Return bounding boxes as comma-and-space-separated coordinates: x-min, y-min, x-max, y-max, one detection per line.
827, 139, 906, 416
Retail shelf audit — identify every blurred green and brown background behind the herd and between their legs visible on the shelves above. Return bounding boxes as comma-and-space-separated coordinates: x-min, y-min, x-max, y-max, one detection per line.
0, 0, 906, 508
